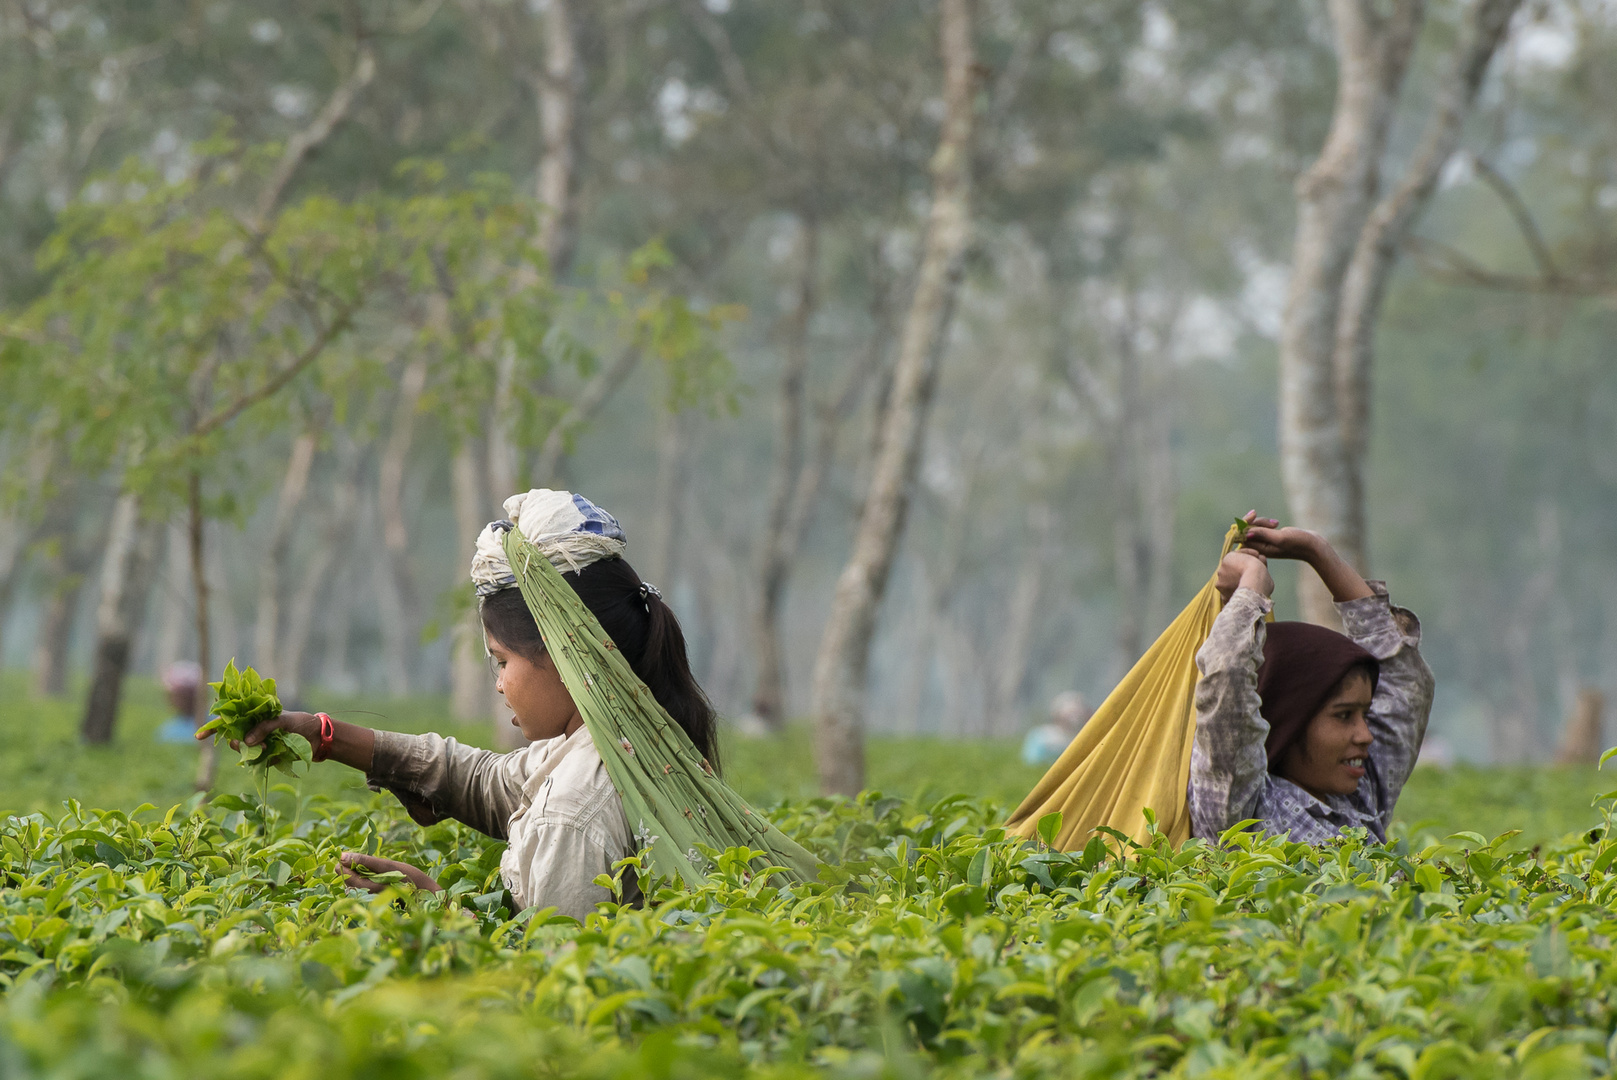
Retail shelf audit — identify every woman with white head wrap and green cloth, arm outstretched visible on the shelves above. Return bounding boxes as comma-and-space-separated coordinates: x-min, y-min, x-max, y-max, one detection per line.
221, 488, 815, 920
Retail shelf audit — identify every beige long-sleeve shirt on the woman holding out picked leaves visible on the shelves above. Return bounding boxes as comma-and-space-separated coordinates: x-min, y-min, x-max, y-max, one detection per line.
367, 728, 640, 922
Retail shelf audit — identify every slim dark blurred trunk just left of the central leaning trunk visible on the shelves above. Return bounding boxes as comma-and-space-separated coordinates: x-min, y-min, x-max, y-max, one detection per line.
752, 215, 820, 729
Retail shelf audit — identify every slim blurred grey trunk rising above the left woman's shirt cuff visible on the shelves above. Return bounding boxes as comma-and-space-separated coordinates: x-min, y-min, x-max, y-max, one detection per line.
377, 361, 427, 695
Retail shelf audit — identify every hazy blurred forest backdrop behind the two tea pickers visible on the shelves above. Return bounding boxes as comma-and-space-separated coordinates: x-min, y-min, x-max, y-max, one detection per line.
0, 0, 1617, 788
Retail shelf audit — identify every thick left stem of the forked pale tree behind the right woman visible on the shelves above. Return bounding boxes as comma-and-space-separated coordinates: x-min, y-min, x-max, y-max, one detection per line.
1279, 0, 1426, 624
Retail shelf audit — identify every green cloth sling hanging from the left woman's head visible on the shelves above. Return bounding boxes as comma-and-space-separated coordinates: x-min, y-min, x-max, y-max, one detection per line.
505, 527, 820, 888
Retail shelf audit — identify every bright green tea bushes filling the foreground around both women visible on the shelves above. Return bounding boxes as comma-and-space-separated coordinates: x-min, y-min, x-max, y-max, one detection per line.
0, 787, 1617, 1080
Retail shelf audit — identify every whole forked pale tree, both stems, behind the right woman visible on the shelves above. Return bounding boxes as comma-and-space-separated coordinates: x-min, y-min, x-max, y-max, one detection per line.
1281, 0, 1520, 626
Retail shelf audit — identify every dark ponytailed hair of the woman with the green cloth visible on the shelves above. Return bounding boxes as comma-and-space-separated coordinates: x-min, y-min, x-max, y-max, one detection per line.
480, 556, 720, 773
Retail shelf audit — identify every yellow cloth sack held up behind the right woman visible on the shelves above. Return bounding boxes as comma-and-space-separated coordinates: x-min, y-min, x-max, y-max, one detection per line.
1006, 525, 1242, 850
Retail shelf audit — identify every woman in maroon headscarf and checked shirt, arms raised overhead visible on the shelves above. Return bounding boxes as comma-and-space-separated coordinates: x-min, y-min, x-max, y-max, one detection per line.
1190, 513, 1433, 842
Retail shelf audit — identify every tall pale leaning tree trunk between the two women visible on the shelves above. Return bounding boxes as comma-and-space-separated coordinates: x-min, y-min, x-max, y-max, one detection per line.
813, 0, 973, 795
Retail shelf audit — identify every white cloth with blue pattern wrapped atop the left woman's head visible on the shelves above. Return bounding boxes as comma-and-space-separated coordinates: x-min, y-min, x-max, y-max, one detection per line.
472, 488, 626, 597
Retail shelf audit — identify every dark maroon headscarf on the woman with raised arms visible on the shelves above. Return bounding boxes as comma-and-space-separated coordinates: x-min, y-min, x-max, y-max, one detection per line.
1258, 622, 1381, 770
